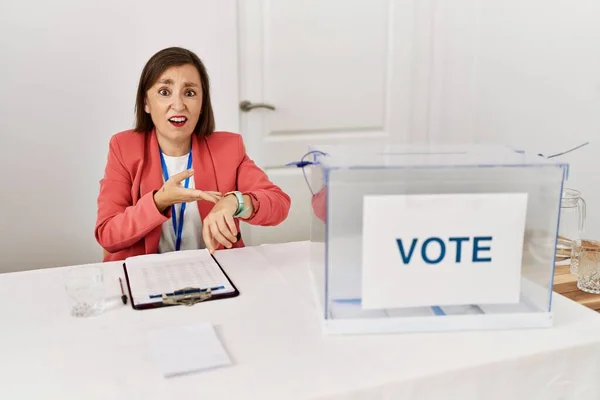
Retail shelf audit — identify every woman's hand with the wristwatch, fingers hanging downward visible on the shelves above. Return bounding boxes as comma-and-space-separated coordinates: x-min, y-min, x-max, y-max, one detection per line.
202, 196, 238, 254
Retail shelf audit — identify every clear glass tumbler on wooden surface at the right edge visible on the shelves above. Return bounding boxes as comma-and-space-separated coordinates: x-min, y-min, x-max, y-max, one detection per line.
573, 240, 600, 294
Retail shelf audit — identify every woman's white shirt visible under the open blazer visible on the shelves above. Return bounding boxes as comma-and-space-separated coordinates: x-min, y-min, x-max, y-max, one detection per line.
158, 154, 206, 253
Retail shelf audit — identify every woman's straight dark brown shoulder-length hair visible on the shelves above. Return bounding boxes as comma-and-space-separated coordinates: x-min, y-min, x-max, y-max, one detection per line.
134, 47, 215, 136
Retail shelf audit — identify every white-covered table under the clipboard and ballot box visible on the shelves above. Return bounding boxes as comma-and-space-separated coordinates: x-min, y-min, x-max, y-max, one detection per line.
0, 243, 600, 400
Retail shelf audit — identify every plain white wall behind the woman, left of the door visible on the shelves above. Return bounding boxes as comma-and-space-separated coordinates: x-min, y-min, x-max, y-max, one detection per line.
0, 0, 239, 272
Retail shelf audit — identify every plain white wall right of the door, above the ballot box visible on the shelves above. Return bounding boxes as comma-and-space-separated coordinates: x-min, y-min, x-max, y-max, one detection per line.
421, 0, 600, 239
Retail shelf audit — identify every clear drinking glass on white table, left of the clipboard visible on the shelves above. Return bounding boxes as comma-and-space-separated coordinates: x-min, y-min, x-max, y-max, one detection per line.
65, 266, 104, 317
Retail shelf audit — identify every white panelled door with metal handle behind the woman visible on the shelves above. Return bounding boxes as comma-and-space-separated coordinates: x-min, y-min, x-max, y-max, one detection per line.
238, 0, 427, 244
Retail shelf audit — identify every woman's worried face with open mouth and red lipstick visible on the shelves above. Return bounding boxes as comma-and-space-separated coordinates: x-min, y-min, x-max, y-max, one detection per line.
144, 64, 202, 142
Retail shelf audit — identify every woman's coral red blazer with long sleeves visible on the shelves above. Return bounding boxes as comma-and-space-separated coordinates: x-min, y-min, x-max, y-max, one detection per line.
94, 130, 291, 261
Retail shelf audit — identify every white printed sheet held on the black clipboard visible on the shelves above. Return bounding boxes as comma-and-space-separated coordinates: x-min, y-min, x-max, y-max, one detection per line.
125, 249, 234, 305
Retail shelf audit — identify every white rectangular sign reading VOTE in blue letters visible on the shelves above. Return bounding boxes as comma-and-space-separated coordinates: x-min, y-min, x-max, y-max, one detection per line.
362, 193, 527, 309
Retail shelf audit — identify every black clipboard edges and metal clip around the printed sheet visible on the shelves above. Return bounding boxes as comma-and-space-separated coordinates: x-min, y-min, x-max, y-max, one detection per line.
123, 254, 240, 310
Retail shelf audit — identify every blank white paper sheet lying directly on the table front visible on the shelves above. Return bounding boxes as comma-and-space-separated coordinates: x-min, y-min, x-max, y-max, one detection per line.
148, 323, 231, 378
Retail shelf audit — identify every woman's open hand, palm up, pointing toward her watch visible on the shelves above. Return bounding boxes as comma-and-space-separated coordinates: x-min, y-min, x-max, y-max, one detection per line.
154, 169, 223, 213
